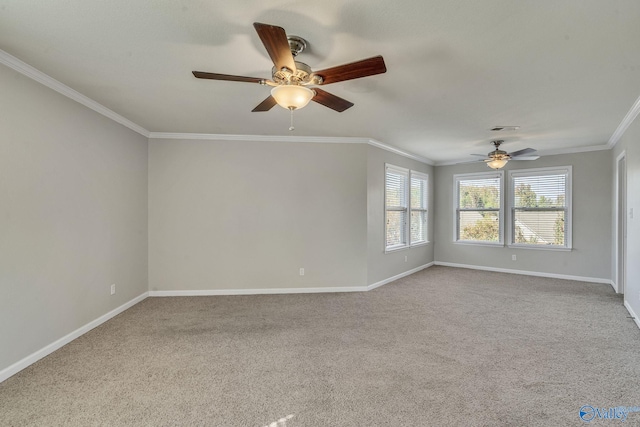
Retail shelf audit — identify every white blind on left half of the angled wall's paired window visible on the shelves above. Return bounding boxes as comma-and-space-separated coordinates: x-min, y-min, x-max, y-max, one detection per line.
385, 165, 409, 249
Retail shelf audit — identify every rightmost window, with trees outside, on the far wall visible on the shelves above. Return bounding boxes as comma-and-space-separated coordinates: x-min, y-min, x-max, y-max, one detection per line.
509, 166, 571, 249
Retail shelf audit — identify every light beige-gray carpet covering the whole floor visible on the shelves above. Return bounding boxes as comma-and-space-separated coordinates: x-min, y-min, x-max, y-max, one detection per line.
0, 267, 640, 427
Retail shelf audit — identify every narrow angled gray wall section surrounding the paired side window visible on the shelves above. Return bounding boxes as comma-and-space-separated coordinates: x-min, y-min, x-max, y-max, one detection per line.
367, 146, 434, 285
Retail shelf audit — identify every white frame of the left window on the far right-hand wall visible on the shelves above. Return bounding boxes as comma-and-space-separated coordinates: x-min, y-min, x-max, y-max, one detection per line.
453, 170, 505, 247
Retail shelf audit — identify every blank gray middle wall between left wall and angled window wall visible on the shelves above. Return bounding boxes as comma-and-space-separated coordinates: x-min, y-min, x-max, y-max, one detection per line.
149, 139, 367, 291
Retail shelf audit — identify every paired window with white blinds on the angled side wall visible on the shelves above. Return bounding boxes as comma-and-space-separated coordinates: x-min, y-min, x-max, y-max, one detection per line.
385, 165, 428, 251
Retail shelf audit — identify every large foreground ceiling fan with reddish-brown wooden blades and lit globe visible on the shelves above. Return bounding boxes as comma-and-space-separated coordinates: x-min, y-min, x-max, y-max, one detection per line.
193, 22, 387, 121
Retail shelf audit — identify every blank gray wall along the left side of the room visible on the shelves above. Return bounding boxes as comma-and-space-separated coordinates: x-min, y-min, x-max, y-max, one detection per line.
0, 65, 147, 370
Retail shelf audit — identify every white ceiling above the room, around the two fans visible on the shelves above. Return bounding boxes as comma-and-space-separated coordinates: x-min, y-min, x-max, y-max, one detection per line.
0, 0, 640, 163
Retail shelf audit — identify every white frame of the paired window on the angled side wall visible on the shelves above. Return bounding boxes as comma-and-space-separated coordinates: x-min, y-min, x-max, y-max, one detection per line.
383, 163, 429, 253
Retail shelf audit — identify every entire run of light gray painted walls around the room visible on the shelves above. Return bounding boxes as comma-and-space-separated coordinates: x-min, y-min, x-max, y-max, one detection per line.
0, 51, 640, 380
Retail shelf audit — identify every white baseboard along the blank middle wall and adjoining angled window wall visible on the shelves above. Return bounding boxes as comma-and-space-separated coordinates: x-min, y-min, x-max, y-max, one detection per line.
149, 262, 433, 297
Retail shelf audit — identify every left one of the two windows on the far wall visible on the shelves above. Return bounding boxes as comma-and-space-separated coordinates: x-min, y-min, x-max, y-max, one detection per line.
454, 171, 504, 245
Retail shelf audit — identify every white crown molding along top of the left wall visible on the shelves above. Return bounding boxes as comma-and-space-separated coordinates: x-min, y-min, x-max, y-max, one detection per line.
0, 49, 149, 138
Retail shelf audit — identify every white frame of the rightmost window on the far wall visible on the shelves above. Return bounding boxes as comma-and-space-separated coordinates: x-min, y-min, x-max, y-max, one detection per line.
507, 165, 573, 251
